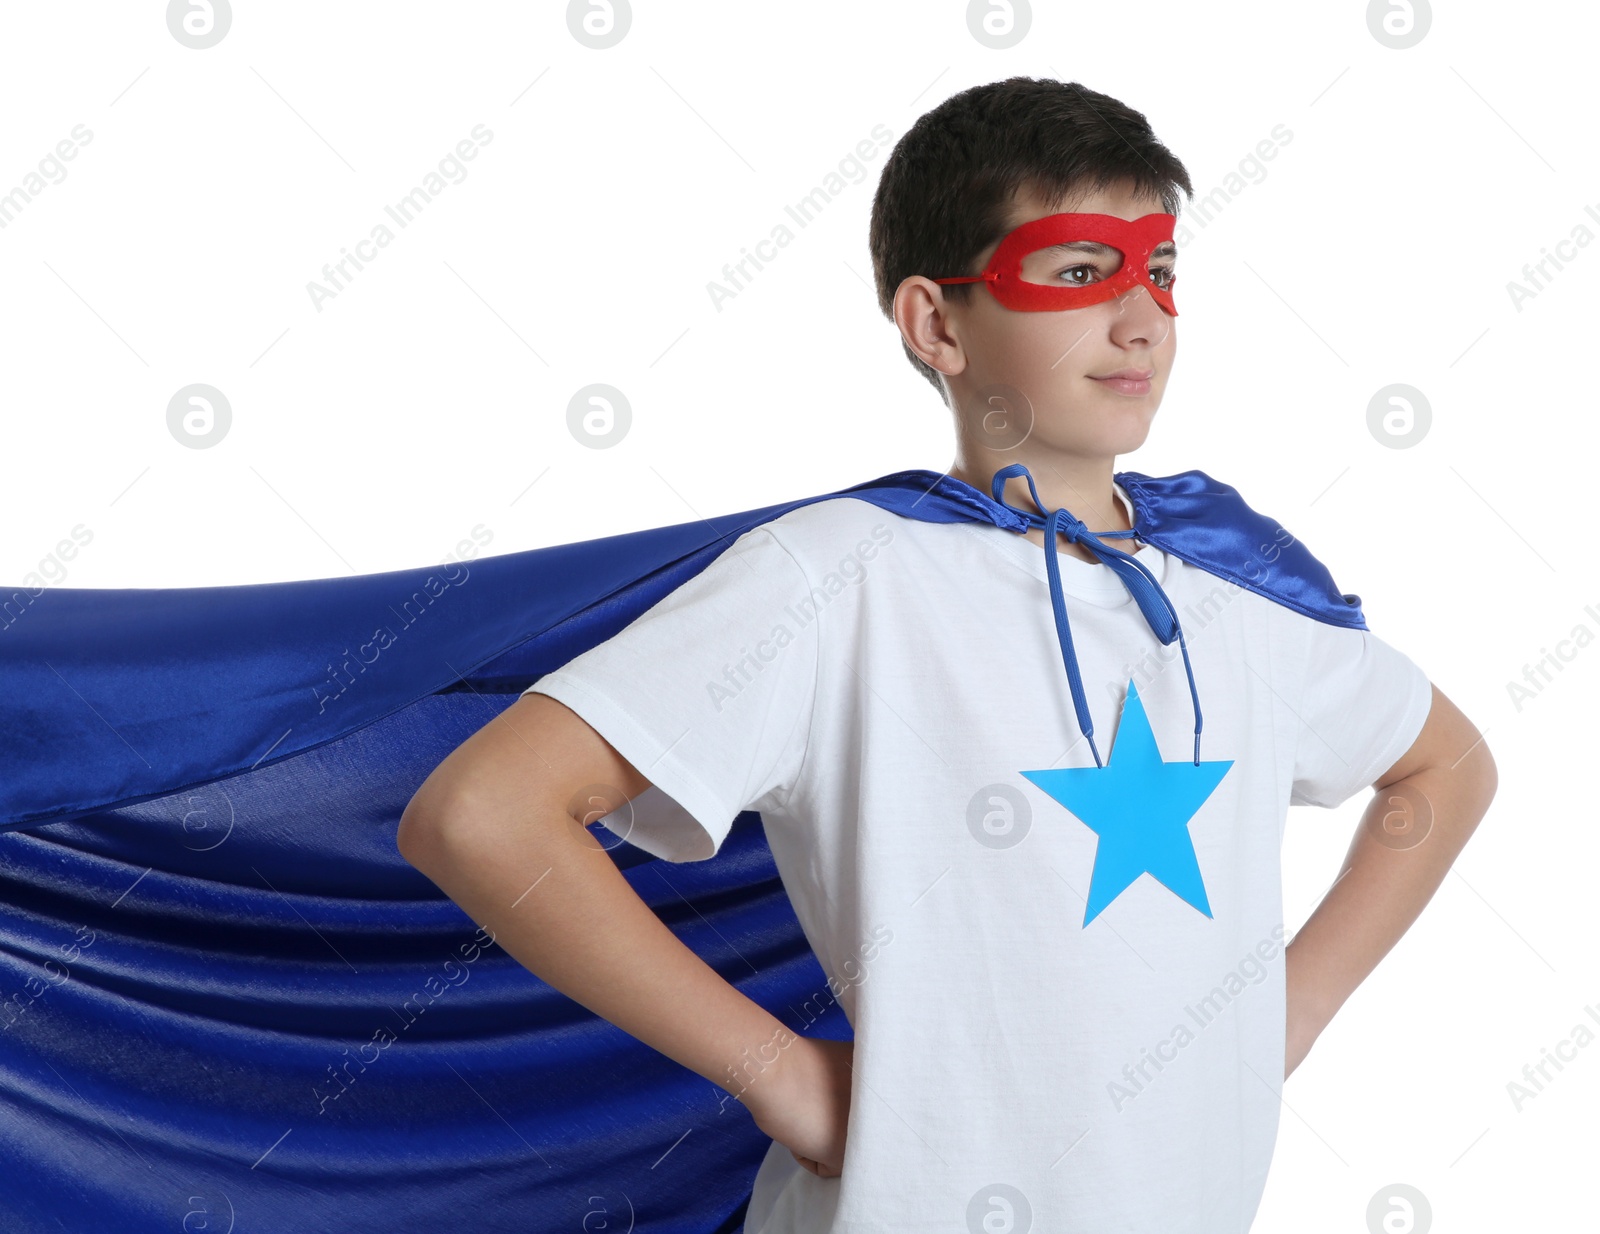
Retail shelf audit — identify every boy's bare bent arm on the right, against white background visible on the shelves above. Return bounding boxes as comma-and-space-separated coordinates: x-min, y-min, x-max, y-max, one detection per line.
1285, 685, 1499, 1076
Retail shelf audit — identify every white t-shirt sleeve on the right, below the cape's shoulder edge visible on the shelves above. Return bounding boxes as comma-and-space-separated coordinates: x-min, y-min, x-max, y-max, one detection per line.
1290, 618, 1434, 810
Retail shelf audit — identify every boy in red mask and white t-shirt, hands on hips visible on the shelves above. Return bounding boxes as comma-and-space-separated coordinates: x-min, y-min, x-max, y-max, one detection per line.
400, 78, 1494, 1234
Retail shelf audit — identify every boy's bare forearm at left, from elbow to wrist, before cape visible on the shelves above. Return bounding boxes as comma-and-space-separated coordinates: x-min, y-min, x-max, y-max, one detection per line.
406, 805, 795, 1096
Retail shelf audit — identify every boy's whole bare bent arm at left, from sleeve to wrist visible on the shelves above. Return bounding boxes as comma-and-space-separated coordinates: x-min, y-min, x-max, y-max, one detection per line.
398, 693, 800, 1119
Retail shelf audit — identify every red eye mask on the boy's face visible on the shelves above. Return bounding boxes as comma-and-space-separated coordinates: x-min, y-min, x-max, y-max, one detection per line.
933, 214, 1178, 317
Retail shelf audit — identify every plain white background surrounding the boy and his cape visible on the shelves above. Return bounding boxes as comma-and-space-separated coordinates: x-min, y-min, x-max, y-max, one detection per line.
0, 0, 1600, 1234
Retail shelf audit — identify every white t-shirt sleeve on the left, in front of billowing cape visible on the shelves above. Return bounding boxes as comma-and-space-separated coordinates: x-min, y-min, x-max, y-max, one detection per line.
525, 527, 818, 861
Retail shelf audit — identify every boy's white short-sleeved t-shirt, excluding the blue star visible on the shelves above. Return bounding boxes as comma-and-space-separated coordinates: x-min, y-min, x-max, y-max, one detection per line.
530, 487, 1432, 1234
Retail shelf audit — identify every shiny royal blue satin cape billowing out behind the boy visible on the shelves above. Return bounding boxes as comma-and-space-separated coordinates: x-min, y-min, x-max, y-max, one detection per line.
0, 471, 1365, 1234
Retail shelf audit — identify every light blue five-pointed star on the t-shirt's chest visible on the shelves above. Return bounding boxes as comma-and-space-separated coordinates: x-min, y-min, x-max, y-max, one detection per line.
1022, 679, 1234, 927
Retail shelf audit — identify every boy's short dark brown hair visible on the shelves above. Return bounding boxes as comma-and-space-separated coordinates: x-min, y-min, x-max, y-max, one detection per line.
869, 77, 1194, 399
